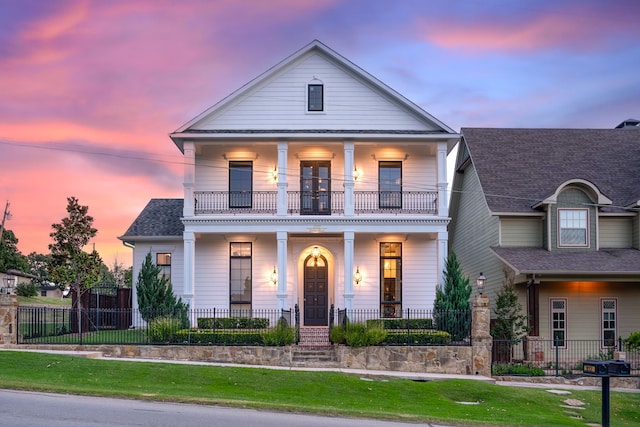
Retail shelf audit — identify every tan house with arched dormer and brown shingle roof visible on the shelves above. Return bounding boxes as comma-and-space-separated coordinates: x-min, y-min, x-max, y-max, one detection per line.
449, 125, 640, 346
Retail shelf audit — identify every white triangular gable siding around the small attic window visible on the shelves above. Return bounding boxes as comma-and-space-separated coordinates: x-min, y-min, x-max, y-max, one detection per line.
193, 53, 436, 130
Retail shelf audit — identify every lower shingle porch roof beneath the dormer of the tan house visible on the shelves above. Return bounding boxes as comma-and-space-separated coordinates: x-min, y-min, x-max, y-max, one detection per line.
491, 247, 640, 275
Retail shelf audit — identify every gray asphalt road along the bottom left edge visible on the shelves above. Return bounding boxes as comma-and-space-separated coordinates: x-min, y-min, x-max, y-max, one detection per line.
0, 390, 460, 427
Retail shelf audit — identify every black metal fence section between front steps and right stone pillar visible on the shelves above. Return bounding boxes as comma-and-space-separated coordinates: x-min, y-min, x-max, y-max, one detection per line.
330, 307, 471, 345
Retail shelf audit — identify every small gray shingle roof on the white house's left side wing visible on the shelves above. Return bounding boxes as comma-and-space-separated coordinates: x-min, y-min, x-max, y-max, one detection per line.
120, 199, 184, 240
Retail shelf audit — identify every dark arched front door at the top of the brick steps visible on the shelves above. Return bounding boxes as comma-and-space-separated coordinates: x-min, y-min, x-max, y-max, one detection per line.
304, 256, 329, 326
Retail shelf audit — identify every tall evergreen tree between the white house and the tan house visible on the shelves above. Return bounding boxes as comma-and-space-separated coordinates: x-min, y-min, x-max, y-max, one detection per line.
433, 252, 471, 341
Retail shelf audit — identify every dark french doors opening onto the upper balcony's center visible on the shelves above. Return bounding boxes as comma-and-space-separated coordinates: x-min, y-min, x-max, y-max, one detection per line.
300, 161, 331, 215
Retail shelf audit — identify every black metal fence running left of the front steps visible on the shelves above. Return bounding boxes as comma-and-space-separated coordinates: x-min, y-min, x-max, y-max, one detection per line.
16, 306, 298, 345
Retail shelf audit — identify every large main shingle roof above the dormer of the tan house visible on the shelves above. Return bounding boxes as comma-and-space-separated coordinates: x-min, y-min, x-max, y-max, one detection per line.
461, 128, 640, 212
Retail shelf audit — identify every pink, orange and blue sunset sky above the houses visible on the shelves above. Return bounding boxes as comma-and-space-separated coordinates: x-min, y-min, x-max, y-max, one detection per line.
0, 0, 640, 266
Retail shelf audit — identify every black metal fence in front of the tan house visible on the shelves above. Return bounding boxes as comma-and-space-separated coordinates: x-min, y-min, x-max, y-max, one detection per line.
492, 338, 640, 376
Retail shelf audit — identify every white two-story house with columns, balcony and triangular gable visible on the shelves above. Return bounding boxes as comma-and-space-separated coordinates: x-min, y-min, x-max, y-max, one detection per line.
120, 41, 459, 332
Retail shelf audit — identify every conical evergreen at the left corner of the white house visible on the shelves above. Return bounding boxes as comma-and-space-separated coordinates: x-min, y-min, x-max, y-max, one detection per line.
136, 253, 189, 327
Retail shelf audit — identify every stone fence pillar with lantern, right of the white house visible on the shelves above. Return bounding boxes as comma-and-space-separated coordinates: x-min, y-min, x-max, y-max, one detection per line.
471, 295, 493, 377
